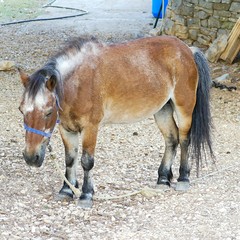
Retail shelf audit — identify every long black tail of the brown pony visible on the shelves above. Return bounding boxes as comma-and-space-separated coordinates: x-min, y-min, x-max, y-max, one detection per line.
190, 47, 214, 175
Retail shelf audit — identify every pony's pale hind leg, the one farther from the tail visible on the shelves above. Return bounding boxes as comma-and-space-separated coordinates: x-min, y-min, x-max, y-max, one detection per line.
154, 102, 178, 186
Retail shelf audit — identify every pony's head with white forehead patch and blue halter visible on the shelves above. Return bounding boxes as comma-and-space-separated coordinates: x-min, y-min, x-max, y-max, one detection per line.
19, 67, 62, 167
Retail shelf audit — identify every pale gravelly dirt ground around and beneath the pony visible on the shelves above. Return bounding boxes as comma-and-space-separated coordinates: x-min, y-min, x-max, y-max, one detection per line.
0, 7, 240, 240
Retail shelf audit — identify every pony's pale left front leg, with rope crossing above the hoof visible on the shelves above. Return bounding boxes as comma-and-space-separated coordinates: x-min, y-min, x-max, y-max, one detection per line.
59, 125, 79, 198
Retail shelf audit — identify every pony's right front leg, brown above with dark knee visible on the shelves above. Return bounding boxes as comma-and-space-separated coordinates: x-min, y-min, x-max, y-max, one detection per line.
79, 125, 98, 208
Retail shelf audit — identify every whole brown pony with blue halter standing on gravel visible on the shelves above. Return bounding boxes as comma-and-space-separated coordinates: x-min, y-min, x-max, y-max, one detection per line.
19, 36, 212, 207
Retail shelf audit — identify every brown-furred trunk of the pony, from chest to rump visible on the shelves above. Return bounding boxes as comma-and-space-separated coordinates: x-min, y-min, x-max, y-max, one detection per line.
60, 37, 198, 131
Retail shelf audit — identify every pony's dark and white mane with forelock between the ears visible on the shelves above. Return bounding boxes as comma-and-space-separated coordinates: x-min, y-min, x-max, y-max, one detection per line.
26, 37, 98, 100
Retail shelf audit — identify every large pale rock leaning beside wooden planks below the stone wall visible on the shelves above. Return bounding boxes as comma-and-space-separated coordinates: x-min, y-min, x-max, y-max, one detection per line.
205, 35, 228, 62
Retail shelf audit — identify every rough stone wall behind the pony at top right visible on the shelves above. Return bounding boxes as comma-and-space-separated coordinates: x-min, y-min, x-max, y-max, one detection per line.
164, 0, 240, 46
